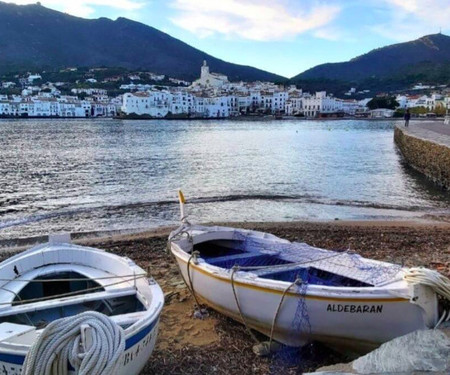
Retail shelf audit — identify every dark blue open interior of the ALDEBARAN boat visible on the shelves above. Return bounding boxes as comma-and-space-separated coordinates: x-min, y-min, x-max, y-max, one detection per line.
194, 240, 373, 287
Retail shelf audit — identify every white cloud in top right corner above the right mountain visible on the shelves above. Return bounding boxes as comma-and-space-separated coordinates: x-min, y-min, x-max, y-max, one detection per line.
373, 0, 450, 41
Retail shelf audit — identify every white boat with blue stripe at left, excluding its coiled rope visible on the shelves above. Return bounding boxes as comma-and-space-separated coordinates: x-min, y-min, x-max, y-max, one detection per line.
0, 236, 164, 375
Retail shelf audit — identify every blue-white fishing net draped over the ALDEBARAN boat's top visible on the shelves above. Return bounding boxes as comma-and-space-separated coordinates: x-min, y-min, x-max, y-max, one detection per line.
227, 231, 402, 287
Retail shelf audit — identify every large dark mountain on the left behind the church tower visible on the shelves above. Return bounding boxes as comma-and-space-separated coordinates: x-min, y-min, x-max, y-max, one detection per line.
0, 2, 285, 81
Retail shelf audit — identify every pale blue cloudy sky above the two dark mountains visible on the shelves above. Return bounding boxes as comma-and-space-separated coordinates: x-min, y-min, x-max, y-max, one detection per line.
6, 0, 450, 77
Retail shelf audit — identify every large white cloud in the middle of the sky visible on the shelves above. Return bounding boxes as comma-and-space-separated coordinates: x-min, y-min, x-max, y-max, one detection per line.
171, 0, 340, 41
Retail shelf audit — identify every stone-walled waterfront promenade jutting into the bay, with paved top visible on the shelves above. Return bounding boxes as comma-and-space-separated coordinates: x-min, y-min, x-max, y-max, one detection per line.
394, 121, 450, 190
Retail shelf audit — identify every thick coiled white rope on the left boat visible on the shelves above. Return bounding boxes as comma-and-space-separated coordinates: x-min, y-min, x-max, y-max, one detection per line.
22, 311, 125, 375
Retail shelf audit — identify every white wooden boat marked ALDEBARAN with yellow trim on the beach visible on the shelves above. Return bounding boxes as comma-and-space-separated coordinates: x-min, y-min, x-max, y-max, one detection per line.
170, 222, 450, 352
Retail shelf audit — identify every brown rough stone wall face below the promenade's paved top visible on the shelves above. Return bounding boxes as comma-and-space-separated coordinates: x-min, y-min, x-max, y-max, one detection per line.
394, 127, 450, 190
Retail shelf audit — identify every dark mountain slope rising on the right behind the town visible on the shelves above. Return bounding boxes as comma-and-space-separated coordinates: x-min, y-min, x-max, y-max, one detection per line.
291, 34, 450, 91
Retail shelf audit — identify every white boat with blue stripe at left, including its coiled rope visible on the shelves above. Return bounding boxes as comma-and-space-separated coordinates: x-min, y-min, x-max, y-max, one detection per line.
0, 236, 164, 375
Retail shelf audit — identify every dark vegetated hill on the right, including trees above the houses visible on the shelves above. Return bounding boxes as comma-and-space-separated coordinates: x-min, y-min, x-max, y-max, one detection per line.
291, 34, 450, 95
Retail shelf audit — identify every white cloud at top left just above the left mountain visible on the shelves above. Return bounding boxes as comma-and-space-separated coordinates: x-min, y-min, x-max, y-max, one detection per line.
6, 0, 145, 17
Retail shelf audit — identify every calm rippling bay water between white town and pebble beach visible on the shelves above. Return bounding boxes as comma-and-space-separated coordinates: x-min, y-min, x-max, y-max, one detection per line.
0, 120, 450, 239
